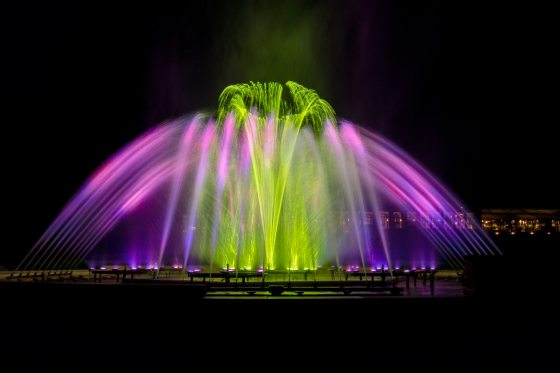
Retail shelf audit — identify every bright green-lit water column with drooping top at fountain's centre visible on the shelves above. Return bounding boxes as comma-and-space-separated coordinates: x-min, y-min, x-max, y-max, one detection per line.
184, 82, 361, 269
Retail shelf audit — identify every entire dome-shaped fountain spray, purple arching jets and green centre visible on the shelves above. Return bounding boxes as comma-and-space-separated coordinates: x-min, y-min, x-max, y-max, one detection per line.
20, 82, 497, 271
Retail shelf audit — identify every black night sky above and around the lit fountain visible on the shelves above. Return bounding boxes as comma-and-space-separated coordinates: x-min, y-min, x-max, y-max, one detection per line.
0, 1, 558, 263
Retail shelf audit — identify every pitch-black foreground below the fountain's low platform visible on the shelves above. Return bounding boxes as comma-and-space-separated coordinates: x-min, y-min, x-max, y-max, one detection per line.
0, 283, 558, 372
